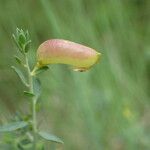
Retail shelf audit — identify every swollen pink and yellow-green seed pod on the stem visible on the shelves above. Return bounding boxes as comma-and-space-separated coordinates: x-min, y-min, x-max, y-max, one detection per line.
37, 39, 101, 71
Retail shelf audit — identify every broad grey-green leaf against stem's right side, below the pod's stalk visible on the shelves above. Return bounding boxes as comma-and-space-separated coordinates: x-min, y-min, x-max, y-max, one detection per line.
33, 77, 41, 98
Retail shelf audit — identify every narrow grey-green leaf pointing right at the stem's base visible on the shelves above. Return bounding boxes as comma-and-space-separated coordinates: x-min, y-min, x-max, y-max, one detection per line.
38, 131, 64, 144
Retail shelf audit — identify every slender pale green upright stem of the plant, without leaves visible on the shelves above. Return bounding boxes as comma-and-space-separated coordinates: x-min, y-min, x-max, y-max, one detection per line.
25, 54, 37, 150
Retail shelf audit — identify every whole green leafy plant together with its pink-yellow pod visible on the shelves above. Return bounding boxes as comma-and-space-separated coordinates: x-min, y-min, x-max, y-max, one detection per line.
0, 28, 101, 150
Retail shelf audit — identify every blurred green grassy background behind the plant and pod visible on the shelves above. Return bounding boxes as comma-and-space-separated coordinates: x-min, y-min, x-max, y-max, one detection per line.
0, 0, 150, 150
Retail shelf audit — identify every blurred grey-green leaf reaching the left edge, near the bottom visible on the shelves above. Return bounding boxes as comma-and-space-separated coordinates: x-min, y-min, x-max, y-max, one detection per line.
0, 121, 28, 132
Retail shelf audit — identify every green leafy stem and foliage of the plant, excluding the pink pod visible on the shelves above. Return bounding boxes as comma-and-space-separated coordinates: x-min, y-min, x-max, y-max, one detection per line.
0, 28, 63, 150
